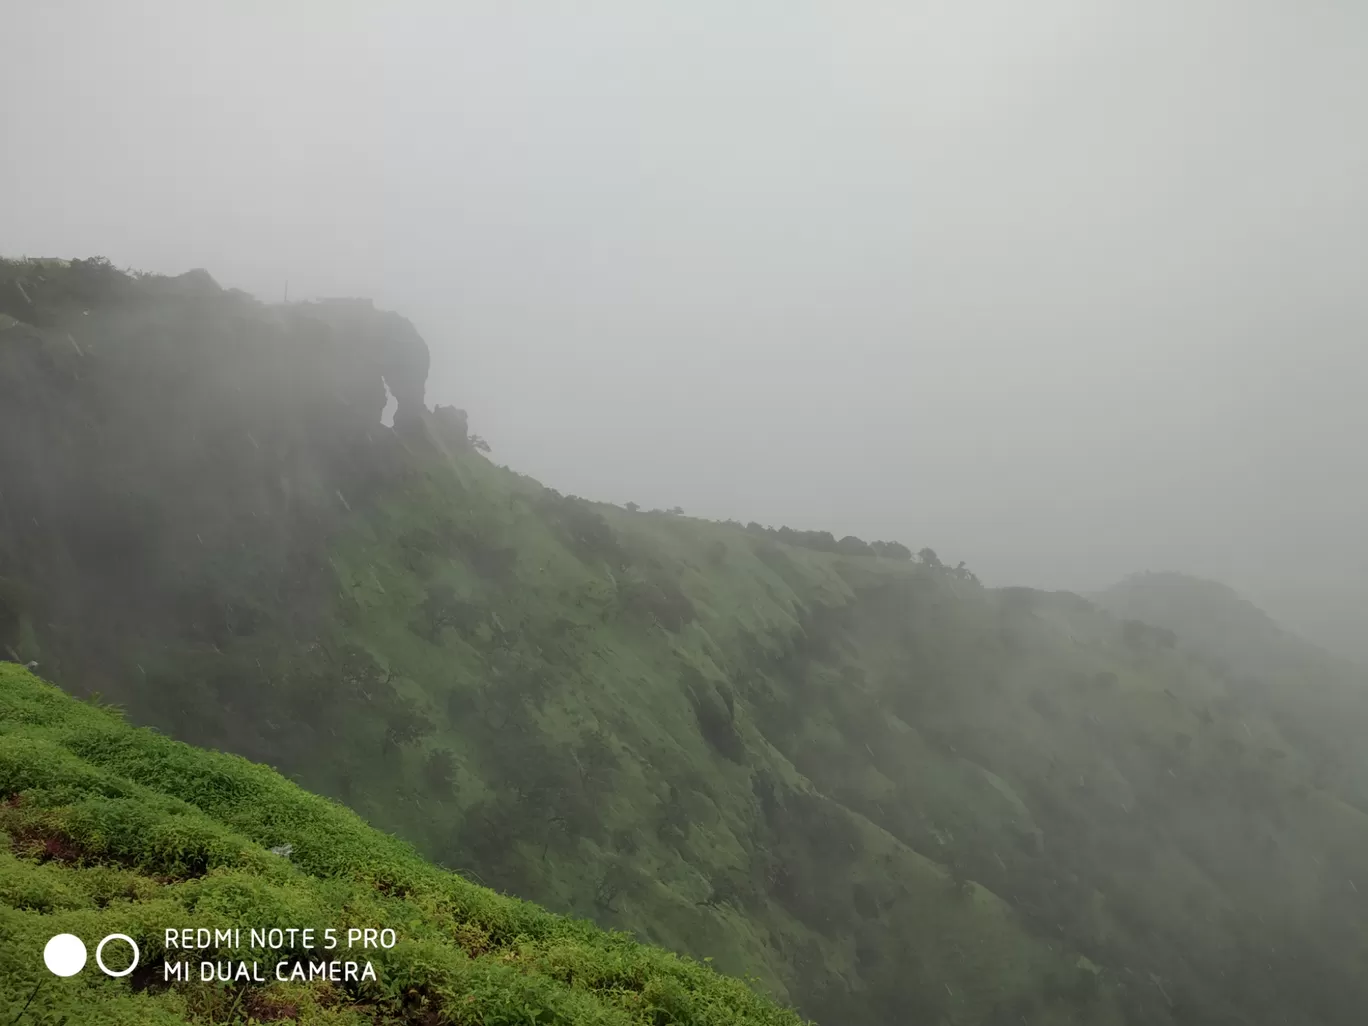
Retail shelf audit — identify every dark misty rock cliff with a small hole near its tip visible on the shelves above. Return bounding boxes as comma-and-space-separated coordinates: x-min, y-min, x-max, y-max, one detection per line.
0, 260, 428, 700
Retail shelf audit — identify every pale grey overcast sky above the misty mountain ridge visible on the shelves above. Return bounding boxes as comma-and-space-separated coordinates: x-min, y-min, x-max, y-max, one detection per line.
0, 0, 1368, 662
